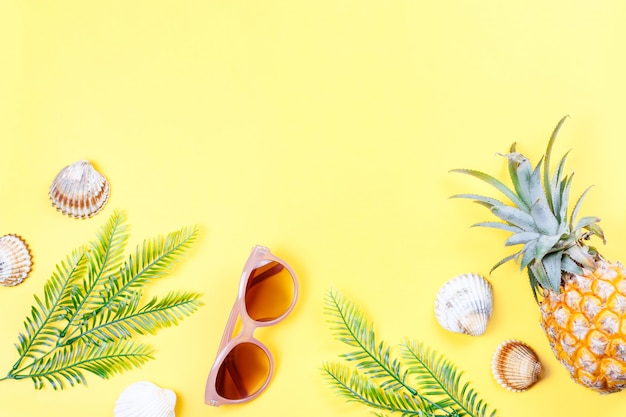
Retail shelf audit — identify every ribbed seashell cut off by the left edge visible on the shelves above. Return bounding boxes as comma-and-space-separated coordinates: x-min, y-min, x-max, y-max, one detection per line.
0, 234, 33, 287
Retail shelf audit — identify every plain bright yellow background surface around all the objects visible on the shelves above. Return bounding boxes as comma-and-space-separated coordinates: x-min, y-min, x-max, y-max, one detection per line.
0, 0, 626, 417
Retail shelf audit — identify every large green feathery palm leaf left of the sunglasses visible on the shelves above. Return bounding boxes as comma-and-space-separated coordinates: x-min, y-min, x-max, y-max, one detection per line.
0, 211, 203, 389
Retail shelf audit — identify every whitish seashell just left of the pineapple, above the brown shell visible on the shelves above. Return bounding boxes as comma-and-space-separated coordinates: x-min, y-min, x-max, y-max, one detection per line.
435, 273, 493, 336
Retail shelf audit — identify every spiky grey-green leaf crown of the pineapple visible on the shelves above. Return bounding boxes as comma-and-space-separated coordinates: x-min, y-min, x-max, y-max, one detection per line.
451, 116, 604, 299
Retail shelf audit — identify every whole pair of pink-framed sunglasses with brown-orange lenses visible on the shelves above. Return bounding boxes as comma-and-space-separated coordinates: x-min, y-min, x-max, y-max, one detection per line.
204, 246, 298, 406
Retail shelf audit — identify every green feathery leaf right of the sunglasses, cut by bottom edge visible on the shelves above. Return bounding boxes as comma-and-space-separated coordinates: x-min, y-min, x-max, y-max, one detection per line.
322, 290, 496, 417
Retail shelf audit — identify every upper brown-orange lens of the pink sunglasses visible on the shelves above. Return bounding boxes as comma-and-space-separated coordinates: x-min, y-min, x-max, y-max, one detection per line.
246, 261, 295, 321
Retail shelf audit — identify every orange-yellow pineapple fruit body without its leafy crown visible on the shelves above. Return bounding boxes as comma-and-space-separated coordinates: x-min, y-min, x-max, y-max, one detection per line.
541, 259, 626, 394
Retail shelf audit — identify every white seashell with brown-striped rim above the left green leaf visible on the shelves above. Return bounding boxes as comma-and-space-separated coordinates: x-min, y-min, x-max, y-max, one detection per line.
48, 160, 111, 219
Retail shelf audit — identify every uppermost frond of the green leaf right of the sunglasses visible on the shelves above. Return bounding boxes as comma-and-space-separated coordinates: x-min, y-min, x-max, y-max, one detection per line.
326, 290, 416, 395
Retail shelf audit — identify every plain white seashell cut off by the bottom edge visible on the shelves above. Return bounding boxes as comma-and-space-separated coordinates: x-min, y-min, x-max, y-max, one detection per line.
113, 381, 176, 417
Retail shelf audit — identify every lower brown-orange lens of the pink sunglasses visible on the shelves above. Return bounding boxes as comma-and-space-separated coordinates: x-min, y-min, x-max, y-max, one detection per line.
215, 343, 270, 400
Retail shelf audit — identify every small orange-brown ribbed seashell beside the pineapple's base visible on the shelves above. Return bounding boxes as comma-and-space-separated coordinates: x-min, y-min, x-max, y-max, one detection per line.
491, 339, 543, 392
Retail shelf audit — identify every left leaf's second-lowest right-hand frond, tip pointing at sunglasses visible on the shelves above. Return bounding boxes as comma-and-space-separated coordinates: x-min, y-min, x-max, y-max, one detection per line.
67, 292, 203, 344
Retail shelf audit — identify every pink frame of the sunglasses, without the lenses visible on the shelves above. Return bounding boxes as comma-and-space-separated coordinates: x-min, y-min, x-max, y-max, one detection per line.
204, 245, 298, 407
